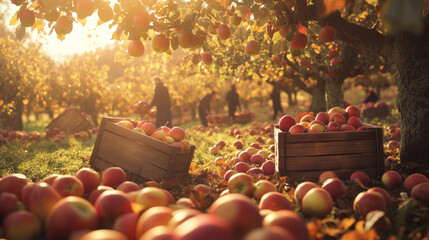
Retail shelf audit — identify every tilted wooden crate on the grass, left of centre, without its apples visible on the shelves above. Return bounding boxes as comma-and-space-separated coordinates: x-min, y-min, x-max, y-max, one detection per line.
90, 117, 195, 182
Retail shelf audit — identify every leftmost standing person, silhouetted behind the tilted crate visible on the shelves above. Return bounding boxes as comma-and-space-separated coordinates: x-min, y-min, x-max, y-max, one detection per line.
150, 77, 173, 128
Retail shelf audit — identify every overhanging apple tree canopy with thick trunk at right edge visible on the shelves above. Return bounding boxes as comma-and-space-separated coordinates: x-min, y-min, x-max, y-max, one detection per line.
3, 0, 429, 163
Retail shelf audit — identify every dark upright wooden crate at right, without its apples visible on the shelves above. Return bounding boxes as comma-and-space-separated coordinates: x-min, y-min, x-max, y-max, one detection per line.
274, 125, 384, 180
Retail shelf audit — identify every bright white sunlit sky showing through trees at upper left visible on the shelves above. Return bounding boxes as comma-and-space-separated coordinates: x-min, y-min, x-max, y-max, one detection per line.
0, 0, 117, 62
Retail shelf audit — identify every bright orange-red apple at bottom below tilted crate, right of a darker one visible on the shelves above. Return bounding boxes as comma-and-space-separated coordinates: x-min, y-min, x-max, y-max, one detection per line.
136, 206, 173, 239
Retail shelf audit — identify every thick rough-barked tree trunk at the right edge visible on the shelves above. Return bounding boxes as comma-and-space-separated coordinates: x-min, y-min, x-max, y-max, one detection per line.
392, 31, 429, 163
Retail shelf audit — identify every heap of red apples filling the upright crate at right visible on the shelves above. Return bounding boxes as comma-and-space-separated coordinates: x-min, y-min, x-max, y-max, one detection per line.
278, 106, 367, 134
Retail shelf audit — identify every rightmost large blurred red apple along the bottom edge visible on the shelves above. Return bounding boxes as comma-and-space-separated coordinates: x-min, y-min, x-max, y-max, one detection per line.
262, 210, 310, 240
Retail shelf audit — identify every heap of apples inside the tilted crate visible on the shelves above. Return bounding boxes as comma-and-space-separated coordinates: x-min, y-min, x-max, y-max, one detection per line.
115, 120, 191, 152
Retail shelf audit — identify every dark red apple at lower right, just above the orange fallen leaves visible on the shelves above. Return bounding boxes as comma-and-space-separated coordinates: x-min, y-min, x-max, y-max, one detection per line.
353, 192, 386, 218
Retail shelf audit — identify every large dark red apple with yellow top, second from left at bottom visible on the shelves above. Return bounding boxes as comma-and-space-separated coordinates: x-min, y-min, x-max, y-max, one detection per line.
45, 196, 98, 240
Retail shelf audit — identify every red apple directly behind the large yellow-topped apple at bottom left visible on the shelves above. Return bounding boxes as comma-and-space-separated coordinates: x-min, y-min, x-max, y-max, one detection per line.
52, 175, 84, 198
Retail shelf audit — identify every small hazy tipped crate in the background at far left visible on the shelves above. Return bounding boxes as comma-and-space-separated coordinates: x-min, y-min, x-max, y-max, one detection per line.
46, 108, 93, 133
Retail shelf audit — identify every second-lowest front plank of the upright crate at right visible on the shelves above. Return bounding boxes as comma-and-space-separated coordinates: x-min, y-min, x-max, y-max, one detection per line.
286, 153, 377, 171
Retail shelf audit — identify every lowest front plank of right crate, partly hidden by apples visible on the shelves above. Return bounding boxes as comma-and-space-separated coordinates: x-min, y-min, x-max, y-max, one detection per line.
285, 168, 377, 181
